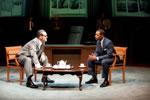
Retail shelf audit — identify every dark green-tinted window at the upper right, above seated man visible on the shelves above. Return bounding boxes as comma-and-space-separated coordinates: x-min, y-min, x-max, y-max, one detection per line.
112, 0, 150, 17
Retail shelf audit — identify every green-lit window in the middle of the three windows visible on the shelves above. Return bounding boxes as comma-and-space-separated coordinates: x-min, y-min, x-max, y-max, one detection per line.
49, 0, 87, 18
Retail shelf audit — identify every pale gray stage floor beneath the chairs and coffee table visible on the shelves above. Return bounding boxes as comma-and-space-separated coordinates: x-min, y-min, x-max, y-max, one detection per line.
0, 66, 150, 100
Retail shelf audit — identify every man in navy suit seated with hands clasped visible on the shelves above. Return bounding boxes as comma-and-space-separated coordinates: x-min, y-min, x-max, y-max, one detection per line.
86, 29, 119, 87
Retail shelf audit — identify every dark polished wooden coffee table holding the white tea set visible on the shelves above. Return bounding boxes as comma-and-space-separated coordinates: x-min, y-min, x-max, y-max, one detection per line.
34, 67, 89, 91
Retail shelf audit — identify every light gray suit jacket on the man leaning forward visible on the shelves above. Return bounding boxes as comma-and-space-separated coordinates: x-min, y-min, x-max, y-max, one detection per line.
18, 38, 45, 64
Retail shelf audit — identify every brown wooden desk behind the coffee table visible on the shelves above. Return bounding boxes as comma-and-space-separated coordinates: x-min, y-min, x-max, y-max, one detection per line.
45, 45, 96, 66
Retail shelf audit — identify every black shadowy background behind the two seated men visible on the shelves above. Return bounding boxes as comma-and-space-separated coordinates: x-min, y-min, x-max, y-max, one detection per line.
0, 0, 150, 65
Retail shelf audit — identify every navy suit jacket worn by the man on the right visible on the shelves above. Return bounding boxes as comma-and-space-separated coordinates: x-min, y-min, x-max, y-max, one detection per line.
94, 37, 116, 60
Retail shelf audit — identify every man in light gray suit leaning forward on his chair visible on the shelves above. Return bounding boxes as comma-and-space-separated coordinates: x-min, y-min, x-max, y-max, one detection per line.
17, 29, 54, 88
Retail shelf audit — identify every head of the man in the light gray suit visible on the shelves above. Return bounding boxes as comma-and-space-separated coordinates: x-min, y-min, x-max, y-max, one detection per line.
37, 29, 48, 42
